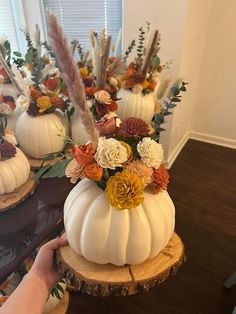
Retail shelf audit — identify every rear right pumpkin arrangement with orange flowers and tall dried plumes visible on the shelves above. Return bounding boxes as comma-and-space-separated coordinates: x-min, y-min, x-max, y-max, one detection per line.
117, 23, 163, 124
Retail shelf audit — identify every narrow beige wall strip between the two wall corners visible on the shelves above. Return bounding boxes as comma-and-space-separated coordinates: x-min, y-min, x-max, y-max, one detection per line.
168, 0, 214, 164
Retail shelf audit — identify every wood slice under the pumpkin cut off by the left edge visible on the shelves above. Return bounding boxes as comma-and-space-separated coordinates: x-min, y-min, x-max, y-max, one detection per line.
0, 171, 38, 212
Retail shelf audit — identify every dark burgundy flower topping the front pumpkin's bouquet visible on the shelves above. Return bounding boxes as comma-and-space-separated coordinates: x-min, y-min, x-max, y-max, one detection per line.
119, 118, 149, 139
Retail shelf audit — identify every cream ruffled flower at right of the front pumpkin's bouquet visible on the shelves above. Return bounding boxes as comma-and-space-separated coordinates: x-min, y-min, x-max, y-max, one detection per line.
137, 137, 164, 169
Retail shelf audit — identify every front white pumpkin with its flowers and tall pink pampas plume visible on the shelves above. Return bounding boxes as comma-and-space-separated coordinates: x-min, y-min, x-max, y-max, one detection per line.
37, 14, 175, 265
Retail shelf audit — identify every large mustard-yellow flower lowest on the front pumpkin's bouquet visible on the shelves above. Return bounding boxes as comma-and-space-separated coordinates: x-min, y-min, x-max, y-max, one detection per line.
105, 170, 144, 210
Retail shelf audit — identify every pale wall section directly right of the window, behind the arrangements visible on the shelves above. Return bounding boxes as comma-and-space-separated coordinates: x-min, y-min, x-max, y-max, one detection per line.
123, 0, 187, 159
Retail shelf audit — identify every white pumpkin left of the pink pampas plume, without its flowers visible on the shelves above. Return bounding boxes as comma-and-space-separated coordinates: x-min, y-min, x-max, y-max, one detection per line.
16, 111, 67, 159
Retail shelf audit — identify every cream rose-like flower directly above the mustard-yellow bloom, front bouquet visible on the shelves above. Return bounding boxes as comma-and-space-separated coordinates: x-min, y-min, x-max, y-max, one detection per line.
94, 137, 128, 169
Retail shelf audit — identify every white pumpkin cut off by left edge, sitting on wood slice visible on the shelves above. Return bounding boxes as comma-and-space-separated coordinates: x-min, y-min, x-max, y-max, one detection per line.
0, 148, 30, 195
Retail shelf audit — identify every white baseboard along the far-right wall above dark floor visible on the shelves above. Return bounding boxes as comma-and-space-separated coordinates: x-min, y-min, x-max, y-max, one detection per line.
189, 131, 236, 149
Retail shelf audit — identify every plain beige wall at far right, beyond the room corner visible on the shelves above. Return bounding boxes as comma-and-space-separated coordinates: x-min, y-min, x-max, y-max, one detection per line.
192, 0, 236, 148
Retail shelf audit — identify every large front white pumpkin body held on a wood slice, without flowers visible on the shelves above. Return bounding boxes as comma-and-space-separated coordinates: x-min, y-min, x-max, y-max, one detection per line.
64, 179, 175, 265
